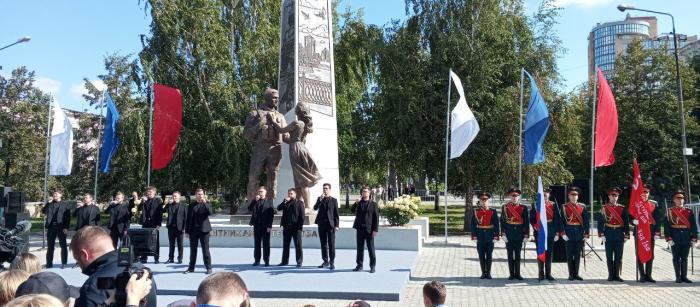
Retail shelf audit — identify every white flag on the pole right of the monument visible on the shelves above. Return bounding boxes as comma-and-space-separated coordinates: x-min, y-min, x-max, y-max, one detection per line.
450, 70, 479, 159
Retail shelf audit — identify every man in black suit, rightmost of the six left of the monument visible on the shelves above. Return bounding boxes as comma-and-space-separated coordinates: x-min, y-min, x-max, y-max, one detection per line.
183, 188, 214, 274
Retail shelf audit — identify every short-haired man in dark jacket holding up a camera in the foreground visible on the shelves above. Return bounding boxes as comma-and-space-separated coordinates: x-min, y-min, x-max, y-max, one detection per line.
70, 226, 157, 307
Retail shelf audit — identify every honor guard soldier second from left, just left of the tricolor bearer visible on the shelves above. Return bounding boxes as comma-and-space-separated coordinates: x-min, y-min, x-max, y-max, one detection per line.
501, 187, 530, 280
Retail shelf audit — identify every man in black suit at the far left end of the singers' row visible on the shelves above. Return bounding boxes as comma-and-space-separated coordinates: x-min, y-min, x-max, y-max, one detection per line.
42, 190, 70, 269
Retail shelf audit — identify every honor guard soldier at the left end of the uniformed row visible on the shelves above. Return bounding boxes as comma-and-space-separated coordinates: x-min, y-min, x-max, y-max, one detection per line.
471, 192, 501, 279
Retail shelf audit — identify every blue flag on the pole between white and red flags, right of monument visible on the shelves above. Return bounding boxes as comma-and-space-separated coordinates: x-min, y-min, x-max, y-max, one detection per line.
523, 71, 549, 164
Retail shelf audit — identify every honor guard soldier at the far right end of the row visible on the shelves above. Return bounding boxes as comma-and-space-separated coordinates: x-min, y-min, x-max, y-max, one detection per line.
664, 190, 698, 283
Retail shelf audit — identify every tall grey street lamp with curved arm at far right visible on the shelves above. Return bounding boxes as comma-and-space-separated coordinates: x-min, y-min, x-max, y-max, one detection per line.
617, 4, 693, 203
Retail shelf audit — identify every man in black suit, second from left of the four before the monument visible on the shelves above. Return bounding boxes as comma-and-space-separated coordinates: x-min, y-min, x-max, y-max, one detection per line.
277, 188, 304, 267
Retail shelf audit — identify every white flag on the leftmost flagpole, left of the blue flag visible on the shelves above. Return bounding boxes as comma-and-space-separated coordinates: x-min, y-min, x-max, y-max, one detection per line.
49, 102, 73, 176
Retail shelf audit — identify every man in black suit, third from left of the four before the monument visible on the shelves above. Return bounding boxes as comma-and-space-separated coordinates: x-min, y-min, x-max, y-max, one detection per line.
314, 183, 340, 270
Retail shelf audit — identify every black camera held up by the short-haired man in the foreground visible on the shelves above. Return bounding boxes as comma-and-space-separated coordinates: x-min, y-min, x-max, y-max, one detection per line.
97, 243, 153, 306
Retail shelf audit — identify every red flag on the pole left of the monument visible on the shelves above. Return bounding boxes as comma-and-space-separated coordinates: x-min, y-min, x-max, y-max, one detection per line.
151, 83, 182, 170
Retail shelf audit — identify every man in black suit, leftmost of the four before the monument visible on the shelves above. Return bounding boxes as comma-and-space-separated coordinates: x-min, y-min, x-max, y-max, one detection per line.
248, 186, 277, 266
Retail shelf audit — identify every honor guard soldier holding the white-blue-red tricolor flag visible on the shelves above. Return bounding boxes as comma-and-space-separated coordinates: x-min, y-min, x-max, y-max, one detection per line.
530, 188, 562, 281
